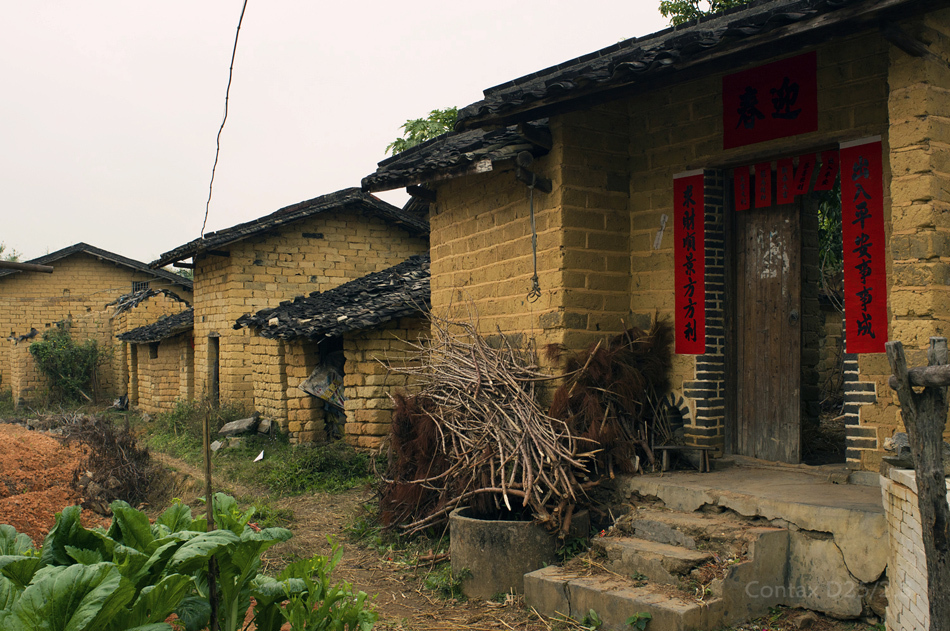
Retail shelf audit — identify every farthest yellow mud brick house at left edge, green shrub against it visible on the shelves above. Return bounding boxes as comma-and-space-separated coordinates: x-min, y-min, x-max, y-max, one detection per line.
0, 243, 192, 400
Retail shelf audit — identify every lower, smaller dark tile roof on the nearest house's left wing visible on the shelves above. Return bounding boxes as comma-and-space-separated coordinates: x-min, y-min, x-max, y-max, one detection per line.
363, 120, 549, 191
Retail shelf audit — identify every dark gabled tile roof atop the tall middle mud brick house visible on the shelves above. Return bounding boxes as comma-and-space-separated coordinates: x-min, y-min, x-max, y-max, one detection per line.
151, 188, 429, 267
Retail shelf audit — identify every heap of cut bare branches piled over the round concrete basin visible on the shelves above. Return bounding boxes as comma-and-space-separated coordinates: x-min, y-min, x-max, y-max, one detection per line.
381, 318, 598, 533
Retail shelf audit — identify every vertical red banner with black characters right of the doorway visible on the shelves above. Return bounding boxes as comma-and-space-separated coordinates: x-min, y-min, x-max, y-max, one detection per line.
839, 137, 887, 353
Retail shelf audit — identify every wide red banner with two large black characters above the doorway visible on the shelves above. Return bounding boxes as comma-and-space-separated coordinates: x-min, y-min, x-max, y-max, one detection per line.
722, 51, 818, 149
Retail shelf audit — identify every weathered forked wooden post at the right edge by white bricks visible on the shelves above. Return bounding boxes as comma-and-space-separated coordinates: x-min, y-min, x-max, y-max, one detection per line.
885, 337, 950, 631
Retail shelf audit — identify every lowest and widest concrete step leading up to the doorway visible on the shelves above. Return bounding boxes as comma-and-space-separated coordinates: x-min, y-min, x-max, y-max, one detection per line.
524, 567, 722, 631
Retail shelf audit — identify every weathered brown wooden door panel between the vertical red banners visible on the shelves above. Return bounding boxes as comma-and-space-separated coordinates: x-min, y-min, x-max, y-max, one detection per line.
734, 202, 801, 463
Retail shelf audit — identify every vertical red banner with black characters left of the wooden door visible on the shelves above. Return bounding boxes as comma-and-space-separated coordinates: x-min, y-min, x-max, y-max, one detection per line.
673, 171, 706, 355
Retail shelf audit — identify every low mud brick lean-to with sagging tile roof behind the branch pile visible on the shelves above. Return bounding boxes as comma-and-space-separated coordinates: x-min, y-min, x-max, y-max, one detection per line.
235, 254, 429, 448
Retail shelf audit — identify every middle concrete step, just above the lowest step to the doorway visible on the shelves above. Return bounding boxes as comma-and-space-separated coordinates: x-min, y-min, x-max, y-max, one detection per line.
593, 537, 715, 585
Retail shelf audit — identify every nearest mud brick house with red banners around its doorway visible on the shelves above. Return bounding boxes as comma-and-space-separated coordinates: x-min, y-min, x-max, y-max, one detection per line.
363, 0, 950, 470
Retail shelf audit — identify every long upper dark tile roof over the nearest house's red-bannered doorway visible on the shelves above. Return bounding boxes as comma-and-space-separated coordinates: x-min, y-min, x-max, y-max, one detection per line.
456, 0, 928, 131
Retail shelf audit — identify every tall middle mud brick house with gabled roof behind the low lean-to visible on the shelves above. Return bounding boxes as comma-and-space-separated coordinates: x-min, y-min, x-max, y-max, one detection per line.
151, 188, 429, 440
